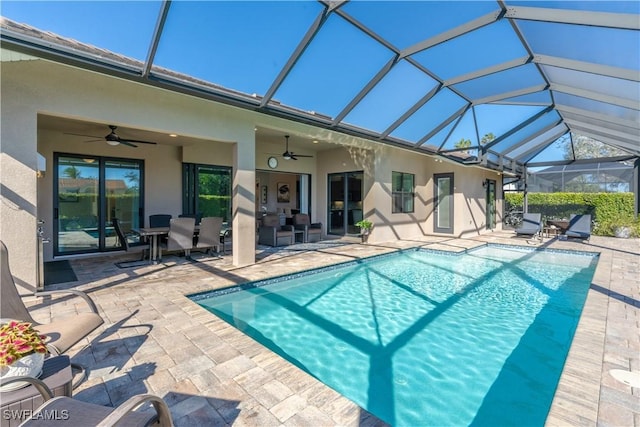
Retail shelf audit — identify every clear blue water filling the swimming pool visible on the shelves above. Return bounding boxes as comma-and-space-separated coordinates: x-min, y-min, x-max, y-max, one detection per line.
191, 246, 597, 426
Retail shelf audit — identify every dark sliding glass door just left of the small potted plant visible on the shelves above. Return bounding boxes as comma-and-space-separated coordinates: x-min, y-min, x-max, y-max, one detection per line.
328, 172, 364, 235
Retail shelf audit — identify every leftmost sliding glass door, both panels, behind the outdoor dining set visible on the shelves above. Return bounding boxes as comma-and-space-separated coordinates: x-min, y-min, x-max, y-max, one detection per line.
53, 153, 144, 255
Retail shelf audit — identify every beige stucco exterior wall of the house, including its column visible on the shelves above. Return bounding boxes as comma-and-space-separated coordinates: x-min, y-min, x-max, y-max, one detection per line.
0, 52, 502, 290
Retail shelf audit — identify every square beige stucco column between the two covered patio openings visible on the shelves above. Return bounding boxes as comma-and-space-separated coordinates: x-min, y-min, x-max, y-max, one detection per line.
231, 132, 256, 266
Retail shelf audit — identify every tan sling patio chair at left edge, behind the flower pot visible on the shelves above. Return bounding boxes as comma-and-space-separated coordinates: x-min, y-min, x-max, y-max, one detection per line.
0, 240, 104, 387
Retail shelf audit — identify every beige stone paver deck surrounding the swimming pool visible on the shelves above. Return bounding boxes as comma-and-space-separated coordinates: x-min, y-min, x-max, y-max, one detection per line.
32, 236, 640, 427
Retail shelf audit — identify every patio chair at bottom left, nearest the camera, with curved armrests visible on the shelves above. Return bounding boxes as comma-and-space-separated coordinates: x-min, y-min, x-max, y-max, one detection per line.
10, 377, 173, 427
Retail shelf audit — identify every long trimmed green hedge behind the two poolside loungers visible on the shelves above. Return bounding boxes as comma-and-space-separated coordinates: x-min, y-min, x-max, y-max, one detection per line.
504, 193, 640, 237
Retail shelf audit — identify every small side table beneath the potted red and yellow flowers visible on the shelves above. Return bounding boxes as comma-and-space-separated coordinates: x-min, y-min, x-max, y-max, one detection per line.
0, 356, 73, 427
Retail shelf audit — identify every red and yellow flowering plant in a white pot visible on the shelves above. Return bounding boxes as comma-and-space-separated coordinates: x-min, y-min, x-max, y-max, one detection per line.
0, 320, 47, 391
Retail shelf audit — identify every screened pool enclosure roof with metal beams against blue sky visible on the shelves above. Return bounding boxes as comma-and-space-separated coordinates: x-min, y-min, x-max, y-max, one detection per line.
0, 1, 640, 175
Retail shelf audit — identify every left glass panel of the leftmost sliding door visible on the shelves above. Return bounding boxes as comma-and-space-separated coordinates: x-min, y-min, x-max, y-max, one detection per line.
54, 156, 100, 254
